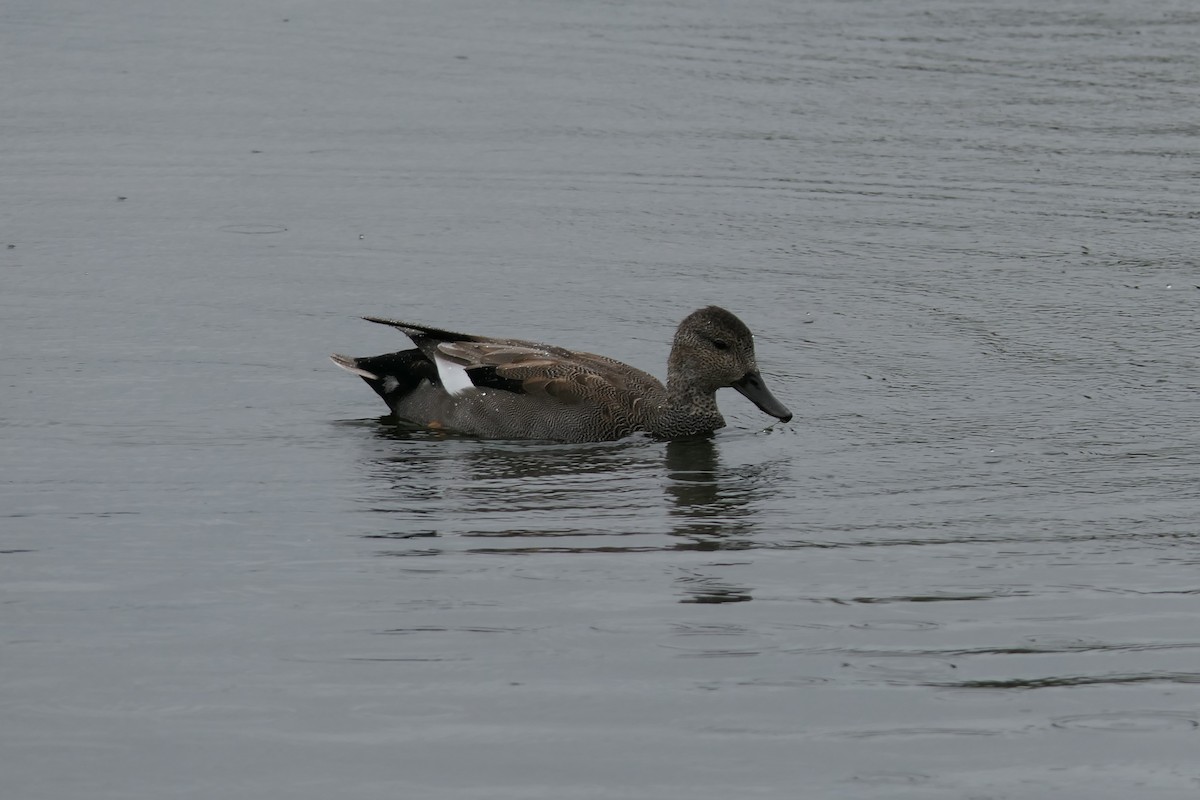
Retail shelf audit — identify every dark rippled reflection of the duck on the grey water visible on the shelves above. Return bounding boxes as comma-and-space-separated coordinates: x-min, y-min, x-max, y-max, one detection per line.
350, 420, 774, 603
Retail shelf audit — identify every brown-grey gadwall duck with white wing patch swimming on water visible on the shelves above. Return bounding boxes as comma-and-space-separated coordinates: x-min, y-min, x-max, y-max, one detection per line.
331, 306, 792, 441
